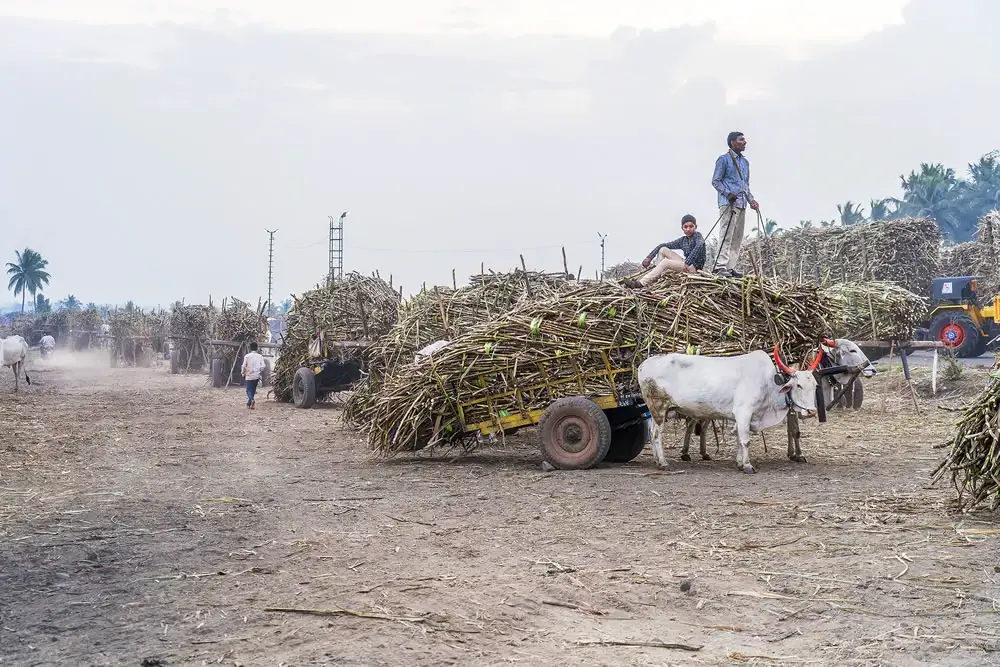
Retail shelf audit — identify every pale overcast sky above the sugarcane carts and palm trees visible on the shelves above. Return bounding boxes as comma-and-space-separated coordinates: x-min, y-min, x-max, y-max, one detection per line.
0, 0, 1000, 306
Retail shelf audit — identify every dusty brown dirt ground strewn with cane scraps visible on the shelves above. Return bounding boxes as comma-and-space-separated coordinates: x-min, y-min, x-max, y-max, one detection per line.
0, 357, 1000, 666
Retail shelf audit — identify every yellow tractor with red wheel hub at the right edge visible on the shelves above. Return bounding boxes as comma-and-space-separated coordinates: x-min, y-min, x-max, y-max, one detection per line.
927, 276, 1000, 358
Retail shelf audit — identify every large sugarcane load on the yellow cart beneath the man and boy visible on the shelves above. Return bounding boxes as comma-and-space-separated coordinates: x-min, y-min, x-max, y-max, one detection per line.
350, 274, 831, 455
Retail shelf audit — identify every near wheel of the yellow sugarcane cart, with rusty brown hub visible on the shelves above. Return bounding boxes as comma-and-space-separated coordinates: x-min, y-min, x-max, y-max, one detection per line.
537, 396, 611, 470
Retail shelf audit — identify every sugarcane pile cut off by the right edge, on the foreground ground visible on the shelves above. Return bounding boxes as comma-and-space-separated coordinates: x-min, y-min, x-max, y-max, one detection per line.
932, 356, 1000, 511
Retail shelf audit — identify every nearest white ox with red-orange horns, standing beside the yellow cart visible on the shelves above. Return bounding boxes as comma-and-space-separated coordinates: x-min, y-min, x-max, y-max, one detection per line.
638, 345, 823, 473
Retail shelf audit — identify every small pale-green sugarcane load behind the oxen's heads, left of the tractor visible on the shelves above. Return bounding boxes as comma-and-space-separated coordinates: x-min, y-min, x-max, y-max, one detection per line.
821, 281, 927, 341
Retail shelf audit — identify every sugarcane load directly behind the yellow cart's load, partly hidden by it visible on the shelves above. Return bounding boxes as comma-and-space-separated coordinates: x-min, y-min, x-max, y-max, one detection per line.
344, 269, 576, 423
